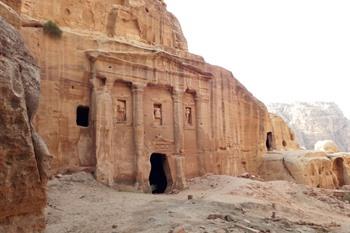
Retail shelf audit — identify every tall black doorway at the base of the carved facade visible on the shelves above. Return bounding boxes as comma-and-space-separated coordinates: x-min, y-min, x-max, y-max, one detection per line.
149, 153, 168, 194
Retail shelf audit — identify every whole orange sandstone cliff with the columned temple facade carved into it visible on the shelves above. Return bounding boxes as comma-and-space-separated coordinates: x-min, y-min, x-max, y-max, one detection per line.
17, 0, 271, 189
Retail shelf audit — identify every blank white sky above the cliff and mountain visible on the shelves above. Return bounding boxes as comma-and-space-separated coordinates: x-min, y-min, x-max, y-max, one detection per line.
166, 0, 350, 117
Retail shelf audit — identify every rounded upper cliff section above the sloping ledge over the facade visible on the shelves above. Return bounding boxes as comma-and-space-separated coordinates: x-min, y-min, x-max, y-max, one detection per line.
22, 0, 187, 50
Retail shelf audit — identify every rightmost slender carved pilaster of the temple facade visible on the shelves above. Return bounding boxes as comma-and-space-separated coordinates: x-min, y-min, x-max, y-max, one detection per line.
195, 93, 206, 176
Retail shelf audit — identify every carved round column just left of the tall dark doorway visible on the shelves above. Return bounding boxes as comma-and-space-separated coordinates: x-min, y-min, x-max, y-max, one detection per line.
132, 84, 146, 189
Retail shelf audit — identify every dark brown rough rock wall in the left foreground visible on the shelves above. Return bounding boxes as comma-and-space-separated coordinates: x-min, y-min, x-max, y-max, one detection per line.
0, 17, 49, 233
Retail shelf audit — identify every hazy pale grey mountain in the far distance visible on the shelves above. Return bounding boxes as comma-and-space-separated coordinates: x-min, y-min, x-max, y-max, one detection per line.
267, 102, 350, 151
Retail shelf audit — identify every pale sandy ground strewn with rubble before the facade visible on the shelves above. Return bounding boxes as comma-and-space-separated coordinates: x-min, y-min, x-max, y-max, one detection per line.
46, 173, 350, 233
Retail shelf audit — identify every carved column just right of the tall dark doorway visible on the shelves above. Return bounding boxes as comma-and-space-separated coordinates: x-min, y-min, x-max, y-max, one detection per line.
173, 89, 187, 189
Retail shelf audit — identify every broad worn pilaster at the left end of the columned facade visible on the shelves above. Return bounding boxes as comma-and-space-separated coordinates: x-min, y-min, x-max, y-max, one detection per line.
92, 79, 114, 186
